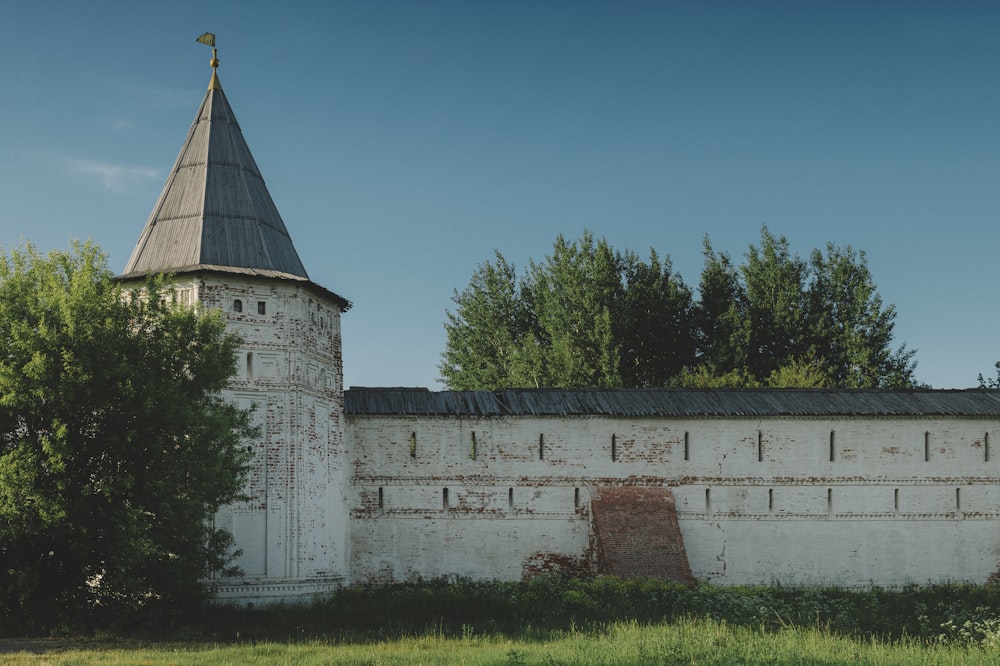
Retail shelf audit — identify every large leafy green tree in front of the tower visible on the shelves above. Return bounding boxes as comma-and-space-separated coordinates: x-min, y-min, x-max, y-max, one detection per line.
0, 243, 255, 628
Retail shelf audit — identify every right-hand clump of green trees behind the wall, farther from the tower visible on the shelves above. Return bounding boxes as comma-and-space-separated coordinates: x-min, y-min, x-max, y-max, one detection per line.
696, 227, 916, 388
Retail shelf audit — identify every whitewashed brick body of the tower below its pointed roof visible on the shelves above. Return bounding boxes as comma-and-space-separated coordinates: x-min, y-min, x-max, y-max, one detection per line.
191, 275, 348, 601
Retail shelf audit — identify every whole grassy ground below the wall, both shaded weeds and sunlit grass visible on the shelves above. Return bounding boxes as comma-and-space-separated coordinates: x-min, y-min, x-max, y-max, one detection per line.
0, 577, 1000, 666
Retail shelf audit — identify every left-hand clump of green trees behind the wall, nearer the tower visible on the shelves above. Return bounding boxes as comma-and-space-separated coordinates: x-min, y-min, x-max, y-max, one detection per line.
439, 231, 695, 390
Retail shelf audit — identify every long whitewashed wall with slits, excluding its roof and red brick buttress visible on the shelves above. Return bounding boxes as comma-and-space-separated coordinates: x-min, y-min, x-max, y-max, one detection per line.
347, 415, 1000, 585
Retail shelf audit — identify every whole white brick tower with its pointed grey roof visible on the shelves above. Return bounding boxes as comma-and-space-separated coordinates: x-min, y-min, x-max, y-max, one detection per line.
119, 49, 351, 602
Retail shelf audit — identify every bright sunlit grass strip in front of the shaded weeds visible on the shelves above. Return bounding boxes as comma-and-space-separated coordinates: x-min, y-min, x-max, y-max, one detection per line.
0, 619, 1000, 666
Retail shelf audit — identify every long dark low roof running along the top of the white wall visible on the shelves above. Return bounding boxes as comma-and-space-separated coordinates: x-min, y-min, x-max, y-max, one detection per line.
344, 386, 1000, 418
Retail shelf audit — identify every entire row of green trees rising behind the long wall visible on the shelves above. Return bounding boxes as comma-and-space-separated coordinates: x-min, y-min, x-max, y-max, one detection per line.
439, 227, 915, 390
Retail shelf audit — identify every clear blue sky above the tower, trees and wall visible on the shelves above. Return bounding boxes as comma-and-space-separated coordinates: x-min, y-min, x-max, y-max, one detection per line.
0, 0, 1000, 388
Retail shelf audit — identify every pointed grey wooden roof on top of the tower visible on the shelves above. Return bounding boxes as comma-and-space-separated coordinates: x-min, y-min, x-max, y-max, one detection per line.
120, 58, 320, 288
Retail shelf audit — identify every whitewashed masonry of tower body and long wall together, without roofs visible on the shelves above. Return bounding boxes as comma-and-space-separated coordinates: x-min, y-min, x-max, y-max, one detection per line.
178, 278, 1000, 601
